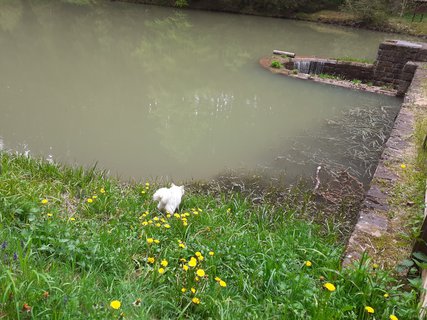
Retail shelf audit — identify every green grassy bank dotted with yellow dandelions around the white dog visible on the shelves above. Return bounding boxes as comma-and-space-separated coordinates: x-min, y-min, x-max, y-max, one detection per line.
0, 154, 418, 320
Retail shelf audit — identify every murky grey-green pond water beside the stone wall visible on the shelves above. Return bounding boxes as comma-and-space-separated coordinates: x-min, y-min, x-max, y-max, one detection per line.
0, 0, 400, 179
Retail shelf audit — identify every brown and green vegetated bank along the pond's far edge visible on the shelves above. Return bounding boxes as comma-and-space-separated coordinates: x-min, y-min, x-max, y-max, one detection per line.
119, 0, 427, 38
